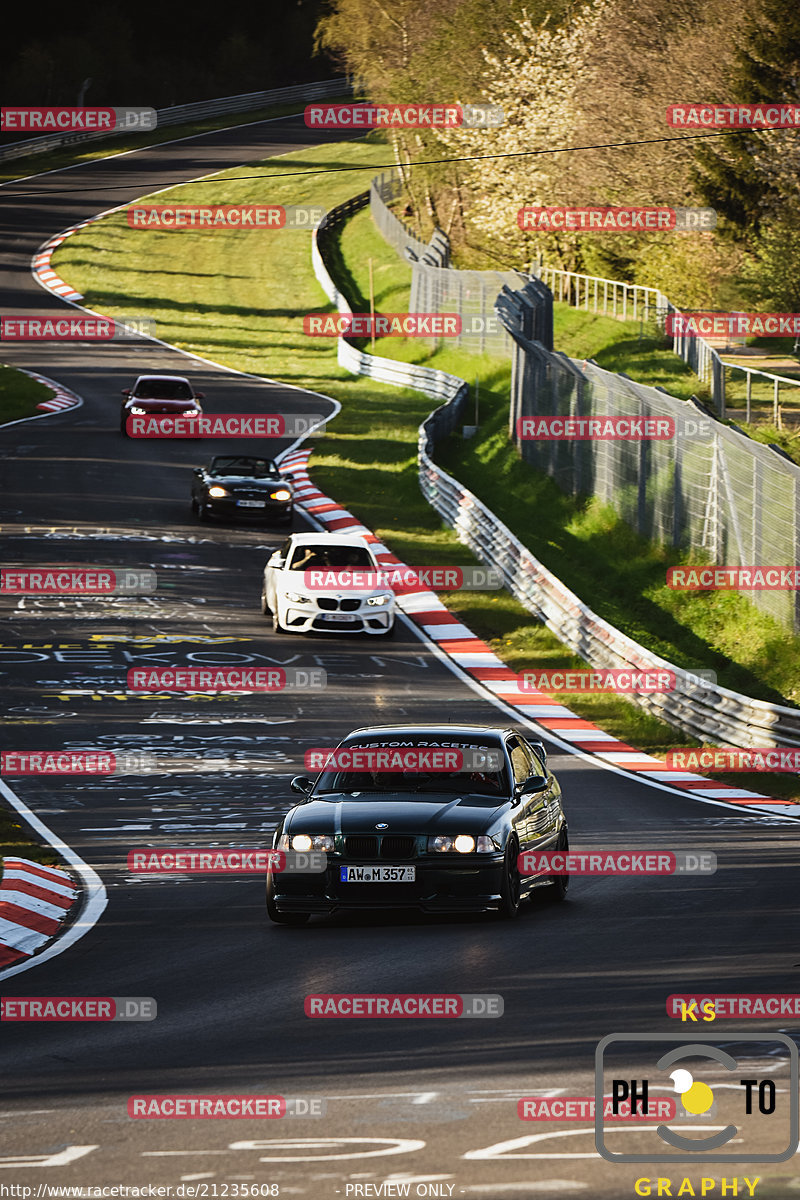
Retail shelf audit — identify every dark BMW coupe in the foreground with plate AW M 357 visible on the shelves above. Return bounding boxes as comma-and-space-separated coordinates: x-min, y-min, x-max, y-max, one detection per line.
266, 725, 569, 925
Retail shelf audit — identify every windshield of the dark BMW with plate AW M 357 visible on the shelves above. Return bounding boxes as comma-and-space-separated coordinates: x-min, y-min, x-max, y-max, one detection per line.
314, 738, 510, 802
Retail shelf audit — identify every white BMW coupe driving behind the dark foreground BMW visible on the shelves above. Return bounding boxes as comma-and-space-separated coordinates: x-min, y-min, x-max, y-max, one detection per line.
261, 533, 395, 637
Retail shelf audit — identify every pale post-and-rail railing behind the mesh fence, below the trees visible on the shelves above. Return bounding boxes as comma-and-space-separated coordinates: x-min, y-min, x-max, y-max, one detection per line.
534, 264, 726, 420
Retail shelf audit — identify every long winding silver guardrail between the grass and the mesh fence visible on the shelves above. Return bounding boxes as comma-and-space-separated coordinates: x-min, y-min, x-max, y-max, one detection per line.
312, 192, 800, 748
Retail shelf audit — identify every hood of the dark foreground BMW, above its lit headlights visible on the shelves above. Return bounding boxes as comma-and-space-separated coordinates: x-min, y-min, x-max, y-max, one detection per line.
285, 792, 509, 835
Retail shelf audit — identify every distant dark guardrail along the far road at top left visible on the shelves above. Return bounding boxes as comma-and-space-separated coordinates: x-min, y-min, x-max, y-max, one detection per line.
0, 76, 351, 162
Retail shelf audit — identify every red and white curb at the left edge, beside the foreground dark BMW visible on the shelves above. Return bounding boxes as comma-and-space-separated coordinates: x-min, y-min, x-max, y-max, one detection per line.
0, 858, 79, 968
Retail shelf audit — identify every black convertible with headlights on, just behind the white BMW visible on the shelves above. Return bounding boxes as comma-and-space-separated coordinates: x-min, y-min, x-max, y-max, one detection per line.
192, 455, 294, 522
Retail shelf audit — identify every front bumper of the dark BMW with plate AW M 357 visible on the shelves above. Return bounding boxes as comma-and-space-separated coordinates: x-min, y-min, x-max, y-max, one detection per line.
267, 854, 504, 914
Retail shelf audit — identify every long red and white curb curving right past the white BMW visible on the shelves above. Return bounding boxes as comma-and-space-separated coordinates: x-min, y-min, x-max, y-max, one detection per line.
281, 449, 800, 817
